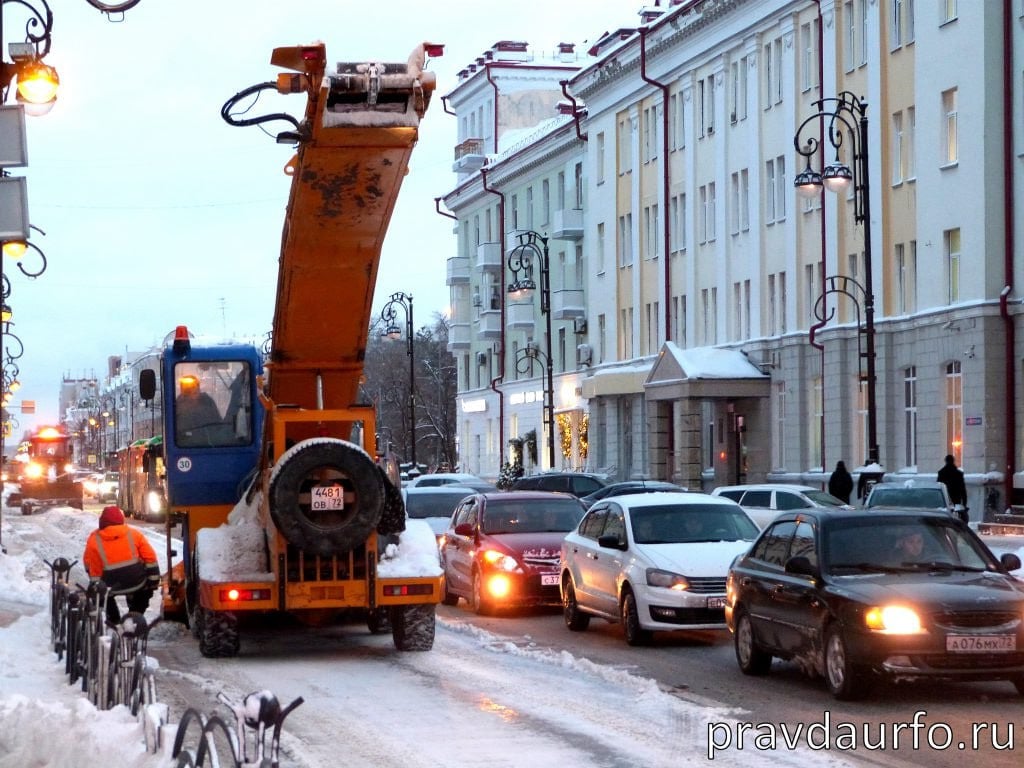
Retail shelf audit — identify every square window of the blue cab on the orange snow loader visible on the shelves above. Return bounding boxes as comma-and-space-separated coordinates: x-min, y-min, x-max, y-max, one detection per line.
173, 360, 252, 447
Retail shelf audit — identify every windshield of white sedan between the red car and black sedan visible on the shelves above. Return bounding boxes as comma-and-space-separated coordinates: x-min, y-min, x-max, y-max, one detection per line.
630, 504, 759, 544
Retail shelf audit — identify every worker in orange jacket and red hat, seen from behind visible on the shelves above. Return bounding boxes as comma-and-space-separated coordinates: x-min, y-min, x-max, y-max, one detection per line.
82, 505, 160, 624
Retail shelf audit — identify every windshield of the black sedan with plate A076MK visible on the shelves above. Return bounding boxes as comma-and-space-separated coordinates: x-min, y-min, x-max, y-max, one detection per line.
821, 515, 998, 575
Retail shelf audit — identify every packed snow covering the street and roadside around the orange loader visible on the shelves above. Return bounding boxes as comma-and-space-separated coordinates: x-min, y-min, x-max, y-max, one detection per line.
0, 507, 864, 768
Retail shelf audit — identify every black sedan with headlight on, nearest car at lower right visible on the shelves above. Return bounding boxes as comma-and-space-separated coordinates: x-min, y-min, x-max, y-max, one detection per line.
725, 509, 1024, 698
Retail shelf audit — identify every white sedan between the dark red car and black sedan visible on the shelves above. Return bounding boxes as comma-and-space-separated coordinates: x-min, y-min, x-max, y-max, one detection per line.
561, 493, 758, 645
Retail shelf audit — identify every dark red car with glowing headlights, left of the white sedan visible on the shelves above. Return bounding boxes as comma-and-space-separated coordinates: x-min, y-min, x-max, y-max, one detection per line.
440, 490, 585, 614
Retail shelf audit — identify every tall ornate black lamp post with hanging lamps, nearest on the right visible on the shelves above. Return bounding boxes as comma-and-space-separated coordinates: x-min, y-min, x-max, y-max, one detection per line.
793, 91, 881, 464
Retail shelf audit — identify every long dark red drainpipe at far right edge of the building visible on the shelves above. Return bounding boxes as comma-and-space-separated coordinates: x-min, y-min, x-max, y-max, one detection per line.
999, 0, 1017, 515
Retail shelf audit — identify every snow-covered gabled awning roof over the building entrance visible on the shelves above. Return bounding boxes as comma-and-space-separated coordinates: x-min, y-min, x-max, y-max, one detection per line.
643, 341, 771, 400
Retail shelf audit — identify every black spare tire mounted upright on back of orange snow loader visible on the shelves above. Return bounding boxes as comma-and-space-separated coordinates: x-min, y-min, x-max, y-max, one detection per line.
270, 439, 384, 557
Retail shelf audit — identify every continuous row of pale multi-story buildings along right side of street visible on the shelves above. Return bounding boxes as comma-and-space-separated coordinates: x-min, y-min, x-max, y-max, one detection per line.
444, 0, 1024, 518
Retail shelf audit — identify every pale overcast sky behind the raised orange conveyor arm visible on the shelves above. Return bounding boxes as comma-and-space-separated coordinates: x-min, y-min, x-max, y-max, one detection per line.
3, 0, 634, 435
